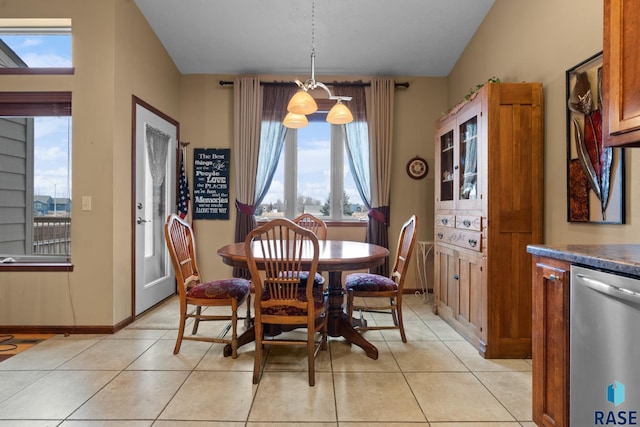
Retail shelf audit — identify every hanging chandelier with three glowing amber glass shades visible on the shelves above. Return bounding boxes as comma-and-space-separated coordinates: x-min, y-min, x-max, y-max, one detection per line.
283, 0, 353, 129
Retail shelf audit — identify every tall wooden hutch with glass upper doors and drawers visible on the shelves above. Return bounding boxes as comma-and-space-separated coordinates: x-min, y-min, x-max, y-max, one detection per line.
434, 83, 544, 358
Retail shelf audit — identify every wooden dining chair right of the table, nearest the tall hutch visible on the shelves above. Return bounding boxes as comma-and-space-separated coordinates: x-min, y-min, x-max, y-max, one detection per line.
345, 215, 418, 342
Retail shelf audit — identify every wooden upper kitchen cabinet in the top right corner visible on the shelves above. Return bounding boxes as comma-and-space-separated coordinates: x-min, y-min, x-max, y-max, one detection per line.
602, 0, 640, 147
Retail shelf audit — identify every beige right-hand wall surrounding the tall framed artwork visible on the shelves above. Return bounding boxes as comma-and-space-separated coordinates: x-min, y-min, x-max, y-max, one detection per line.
448, 0, 640, 244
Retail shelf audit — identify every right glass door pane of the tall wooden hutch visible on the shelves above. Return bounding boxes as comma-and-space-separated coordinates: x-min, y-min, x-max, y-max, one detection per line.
458, 116, 478, 200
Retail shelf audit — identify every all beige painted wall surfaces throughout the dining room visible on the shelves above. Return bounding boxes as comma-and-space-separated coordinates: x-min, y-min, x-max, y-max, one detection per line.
8, 0, 616, 326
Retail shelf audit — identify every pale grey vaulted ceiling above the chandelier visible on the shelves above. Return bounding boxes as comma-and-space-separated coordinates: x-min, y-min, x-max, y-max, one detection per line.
135, 0, 494, 77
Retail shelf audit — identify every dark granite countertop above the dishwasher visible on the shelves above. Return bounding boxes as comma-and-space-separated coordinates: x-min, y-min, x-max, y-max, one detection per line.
527, 245, 640, 277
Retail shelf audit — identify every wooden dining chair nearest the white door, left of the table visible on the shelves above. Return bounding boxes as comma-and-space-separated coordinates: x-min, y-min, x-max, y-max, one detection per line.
164, 214, 251, 359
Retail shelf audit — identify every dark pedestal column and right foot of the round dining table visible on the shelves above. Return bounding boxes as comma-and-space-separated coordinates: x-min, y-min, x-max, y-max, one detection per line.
327, 271, 378, 360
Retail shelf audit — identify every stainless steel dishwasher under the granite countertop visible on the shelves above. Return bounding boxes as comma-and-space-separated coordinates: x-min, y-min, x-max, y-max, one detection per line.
569, 266, 640, 427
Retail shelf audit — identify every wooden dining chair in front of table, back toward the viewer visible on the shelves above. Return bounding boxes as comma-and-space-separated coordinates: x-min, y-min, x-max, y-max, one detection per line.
245, 218, 327, 386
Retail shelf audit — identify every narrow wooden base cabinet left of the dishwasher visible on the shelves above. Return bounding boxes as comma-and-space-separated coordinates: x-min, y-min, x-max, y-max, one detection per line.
532, 256, 571, 427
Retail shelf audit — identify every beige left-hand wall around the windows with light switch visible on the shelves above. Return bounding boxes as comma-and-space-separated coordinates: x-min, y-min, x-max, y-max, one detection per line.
0, 0, 180, 326
